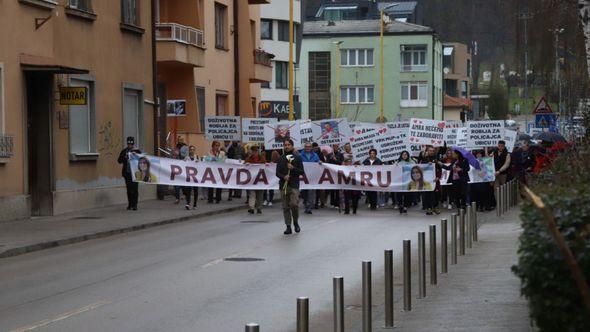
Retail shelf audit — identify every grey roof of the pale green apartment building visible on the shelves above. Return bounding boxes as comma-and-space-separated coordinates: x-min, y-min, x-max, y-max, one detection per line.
303, 20, 434, 36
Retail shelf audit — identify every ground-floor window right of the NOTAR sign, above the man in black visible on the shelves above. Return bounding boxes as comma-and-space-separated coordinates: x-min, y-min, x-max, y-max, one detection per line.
123, 88, 143, 148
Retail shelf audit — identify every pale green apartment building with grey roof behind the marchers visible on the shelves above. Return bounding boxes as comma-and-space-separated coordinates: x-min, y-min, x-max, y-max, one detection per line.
298, 20, 443, 122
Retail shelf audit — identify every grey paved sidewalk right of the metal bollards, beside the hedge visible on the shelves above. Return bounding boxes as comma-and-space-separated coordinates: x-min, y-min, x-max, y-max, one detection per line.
373, 208, 533, 331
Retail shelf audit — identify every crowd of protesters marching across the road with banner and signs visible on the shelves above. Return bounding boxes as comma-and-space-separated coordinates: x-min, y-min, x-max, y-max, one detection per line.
119, 137, 552, 234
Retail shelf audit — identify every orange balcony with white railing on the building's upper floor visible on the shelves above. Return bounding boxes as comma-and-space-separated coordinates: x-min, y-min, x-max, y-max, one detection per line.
156, 23, 205, 67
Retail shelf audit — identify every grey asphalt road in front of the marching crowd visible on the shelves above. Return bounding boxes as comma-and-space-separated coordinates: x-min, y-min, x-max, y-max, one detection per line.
0, 205, 458, 332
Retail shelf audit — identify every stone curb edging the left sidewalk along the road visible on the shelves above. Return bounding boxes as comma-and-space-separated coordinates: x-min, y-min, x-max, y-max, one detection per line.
0, 205, 252, 259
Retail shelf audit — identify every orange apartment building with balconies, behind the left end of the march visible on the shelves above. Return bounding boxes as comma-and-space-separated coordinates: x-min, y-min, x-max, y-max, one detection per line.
156, 0, 272, 149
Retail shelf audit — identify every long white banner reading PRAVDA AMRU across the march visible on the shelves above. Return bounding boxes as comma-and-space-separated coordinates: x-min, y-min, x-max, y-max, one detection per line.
129, 153, 435, 192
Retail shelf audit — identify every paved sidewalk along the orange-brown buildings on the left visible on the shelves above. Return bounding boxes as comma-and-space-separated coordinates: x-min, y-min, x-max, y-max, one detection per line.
0, 193, 260, 258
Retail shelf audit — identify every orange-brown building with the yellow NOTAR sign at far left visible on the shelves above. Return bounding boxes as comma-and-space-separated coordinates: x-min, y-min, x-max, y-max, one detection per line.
0, 0, 156, 221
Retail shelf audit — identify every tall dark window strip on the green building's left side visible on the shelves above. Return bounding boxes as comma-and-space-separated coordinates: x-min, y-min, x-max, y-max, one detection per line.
308, 52, 332, 120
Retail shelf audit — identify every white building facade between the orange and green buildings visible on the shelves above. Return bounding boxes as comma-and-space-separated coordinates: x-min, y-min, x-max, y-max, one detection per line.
259, 0, 301, 119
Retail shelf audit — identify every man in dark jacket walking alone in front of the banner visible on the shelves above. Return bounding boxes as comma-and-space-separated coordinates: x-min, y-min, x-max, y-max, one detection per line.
276, 139, 305, 235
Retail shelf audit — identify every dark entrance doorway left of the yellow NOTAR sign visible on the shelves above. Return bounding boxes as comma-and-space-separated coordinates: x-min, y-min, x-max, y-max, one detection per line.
25, 72, 53, 216
